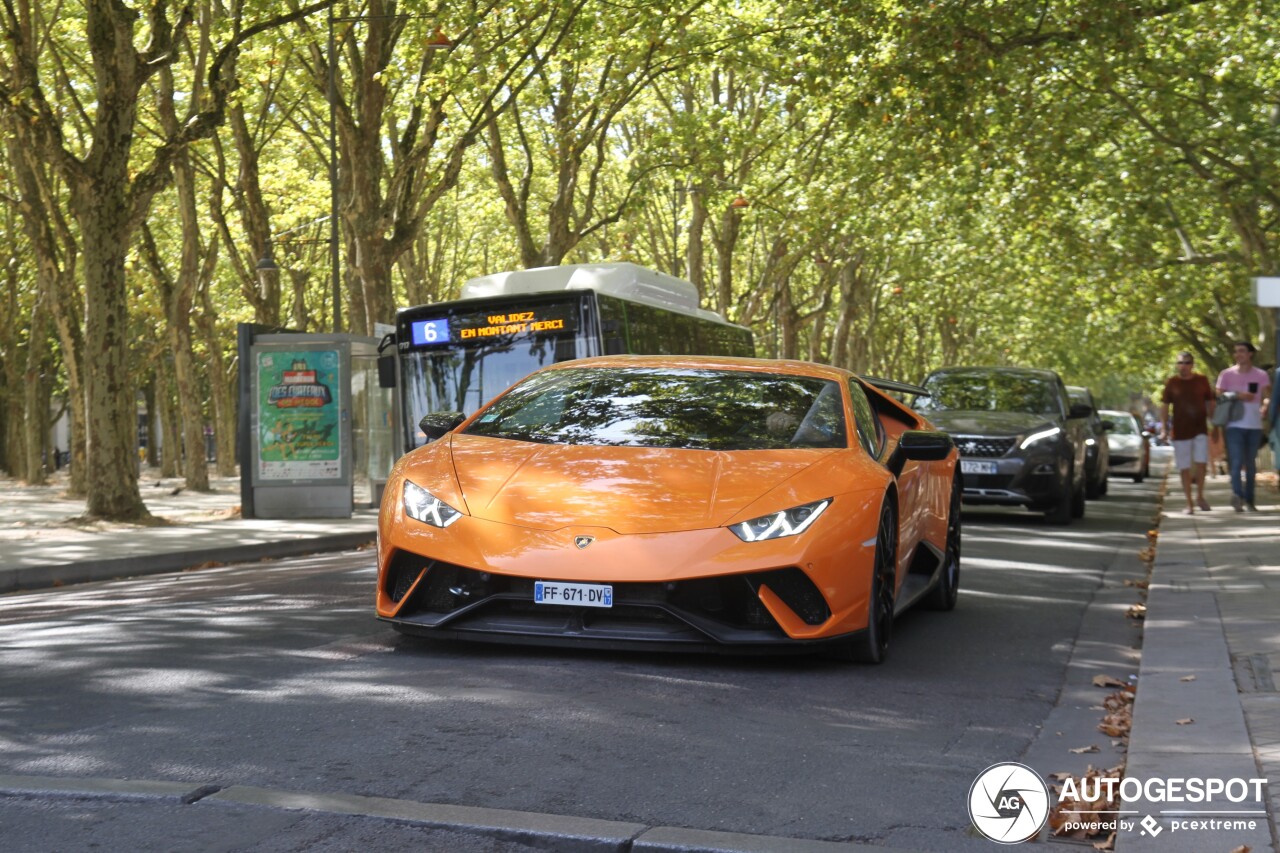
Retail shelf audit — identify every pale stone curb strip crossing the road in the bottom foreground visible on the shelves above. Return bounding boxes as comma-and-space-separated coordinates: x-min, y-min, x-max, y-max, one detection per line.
0, 775, 911, 853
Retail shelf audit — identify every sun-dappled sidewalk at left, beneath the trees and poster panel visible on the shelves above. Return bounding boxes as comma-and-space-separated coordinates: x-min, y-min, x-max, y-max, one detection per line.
0, 471, 378, 593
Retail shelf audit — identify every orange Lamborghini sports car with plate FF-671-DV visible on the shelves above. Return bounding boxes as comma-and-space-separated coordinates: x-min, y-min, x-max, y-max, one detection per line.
378, 356, 961, 662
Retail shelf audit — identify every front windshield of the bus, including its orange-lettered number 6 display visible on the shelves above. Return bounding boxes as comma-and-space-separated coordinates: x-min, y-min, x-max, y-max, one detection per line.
399, 297, 599, 448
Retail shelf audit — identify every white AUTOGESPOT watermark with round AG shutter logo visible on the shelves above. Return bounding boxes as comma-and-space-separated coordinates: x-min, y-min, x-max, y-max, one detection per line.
969, 762, 1268, 844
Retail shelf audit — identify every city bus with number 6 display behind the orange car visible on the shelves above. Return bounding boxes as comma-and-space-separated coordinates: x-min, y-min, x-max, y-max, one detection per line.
384, 263, 755, 450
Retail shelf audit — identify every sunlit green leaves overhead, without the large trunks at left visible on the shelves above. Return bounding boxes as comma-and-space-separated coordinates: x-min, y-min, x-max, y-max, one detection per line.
0, 0, 1280, 481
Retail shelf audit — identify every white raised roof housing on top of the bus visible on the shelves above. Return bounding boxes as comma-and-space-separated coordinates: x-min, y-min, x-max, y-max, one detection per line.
460, 261, 742, 323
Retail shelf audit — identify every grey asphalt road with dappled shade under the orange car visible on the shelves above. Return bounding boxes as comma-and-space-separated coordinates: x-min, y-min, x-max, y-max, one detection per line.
0, 480, 1157, 852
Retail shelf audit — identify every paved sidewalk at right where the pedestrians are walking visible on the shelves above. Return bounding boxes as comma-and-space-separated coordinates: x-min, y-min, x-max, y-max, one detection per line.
1116, 470, 1280, 853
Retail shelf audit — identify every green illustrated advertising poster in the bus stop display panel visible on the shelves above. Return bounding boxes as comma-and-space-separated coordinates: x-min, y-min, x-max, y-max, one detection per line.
257, 350, 342, 480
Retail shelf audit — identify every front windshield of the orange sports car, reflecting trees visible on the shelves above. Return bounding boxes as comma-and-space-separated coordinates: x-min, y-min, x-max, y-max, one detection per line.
466, 368, 846, 451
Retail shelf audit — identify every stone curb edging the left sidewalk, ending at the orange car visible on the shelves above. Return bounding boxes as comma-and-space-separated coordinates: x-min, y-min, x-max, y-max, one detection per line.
0, 530, 376, 594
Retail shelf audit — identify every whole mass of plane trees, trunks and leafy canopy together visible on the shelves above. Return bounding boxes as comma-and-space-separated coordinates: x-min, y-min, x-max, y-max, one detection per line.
0, 0, 1280, 516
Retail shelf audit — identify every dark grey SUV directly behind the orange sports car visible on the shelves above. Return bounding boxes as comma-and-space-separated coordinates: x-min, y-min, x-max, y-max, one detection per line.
914, 368, 1089, 524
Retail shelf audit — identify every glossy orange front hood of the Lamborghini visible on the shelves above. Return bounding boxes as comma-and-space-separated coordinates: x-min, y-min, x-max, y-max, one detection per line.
452, 435, 835, 534
